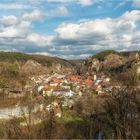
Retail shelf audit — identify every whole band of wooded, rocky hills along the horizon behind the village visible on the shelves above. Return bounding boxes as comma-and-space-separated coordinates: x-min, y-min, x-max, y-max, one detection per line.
0, 50, 140, 73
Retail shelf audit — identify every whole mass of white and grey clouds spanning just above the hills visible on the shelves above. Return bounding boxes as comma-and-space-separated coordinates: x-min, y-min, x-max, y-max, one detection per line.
0, 10, 140, 58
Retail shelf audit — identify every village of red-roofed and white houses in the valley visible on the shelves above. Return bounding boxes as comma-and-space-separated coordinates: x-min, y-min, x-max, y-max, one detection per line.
27, 73, 113, 118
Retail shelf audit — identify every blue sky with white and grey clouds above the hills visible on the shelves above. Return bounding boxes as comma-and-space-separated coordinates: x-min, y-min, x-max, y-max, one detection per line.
0, 0, 140, 59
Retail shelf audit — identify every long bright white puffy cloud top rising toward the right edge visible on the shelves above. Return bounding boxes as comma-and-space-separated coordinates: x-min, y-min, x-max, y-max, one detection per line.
55, 10, 140, 39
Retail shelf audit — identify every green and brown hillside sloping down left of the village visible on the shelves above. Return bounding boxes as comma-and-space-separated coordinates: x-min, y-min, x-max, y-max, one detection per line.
0, 52, 77, 87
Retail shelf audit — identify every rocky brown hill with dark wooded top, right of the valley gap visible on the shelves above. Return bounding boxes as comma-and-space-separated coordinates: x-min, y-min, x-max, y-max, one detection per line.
81, 50, 140, 74
